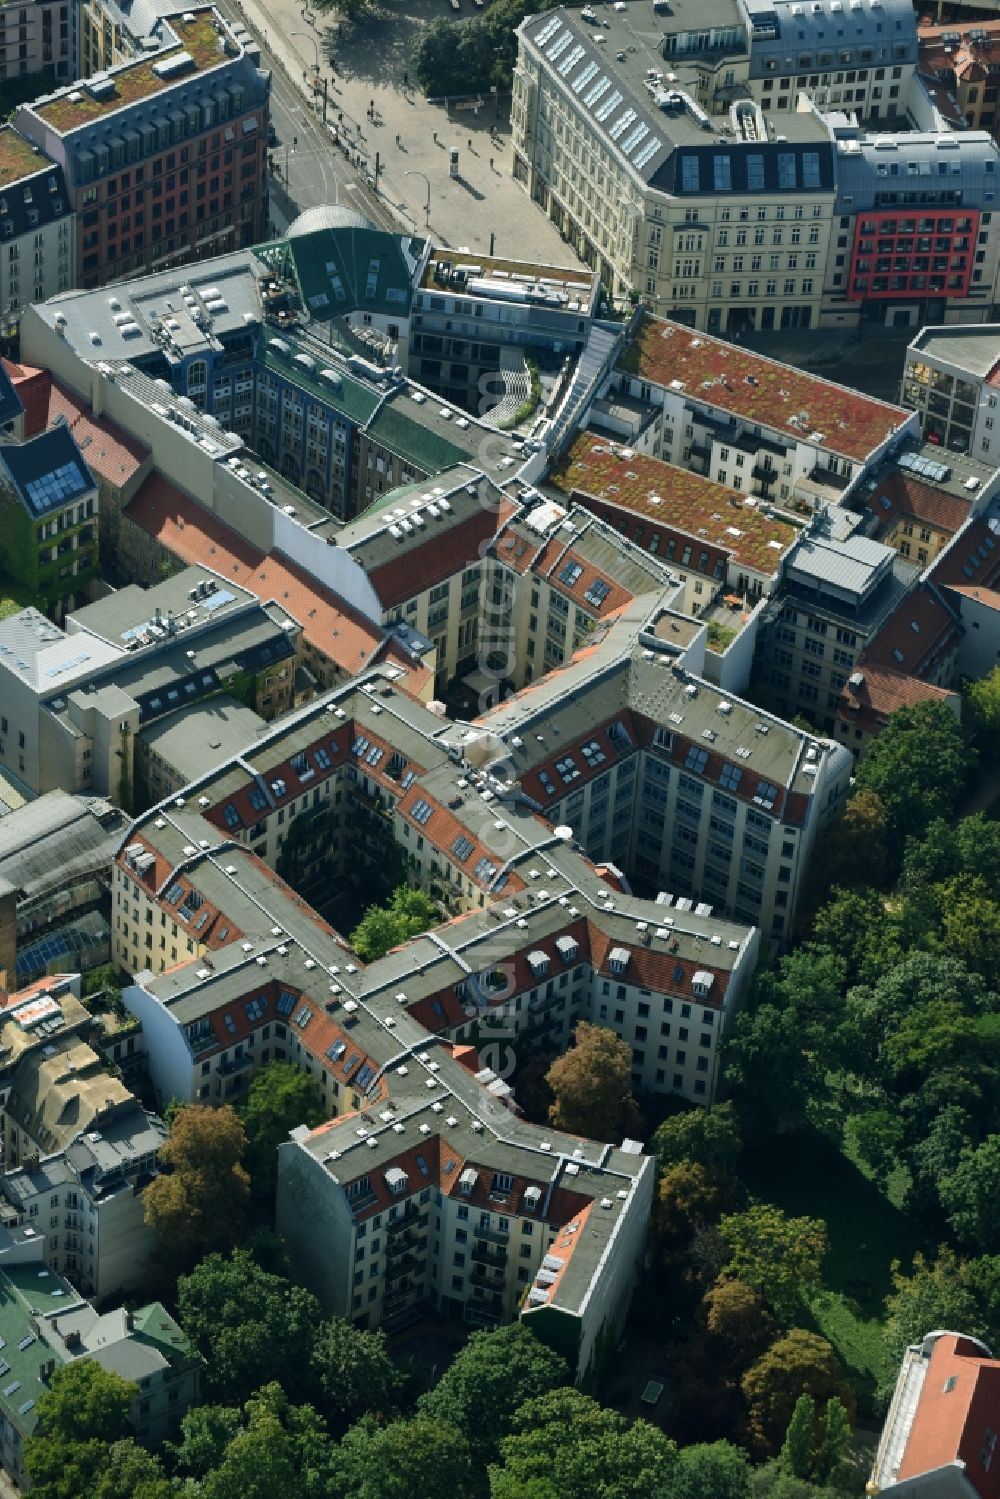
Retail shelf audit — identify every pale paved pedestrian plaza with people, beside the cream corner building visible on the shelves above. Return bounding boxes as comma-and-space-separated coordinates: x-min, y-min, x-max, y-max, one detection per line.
233, 0, 577, 265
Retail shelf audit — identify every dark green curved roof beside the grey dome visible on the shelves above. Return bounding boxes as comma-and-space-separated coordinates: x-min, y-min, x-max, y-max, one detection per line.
288, 226, 420, 322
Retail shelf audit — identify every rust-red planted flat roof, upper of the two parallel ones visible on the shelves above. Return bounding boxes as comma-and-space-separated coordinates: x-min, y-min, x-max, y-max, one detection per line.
622, 316, 913, 462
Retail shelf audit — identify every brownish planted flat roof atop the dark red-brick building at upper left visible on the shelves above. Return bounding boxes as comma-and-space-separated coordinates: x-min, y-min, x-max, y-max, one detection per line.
34, 9, 233, 135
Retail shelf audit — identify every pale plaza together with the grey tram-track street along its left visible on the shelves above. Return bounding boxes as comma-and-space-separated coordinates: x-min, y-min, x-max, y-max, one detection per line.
222, 0, 576, 264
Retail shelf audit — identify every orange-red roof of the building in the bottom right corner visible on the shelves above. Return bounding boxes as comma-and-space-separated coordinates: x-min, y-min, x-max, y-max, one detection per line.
898, 1334, 1000, 1499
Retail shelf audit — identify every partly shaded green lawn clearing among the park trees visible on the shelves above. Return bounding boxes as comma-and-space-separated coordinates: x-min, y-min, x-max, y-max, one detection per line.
741, 1136, 927, 1418
